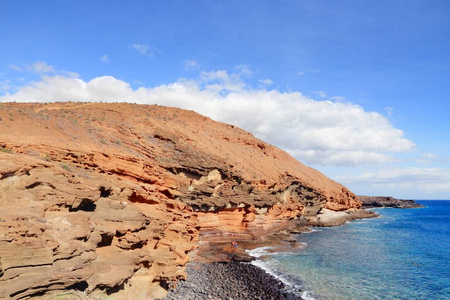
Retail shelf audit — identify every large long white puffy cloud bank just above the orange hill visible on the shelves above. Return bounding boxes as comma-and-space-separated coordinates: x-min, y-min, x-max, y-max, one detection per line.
0, 71, 415, 166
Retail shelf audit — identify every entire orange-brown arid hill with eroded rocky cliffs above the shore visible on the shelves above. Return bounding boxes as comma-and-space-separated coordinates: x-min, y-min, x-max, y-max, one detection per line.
0, 103, 361, 299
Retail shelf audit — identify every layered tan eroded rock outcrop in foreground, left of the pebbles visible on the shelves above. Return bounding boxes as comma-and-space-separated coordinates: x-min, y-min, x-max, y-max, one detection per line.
0, 154, 197, 299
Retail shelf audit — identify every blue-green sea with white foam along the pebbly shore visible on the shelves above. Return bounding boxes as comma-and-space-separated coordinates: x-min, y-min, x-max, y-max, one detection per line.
251, 201, 450, 300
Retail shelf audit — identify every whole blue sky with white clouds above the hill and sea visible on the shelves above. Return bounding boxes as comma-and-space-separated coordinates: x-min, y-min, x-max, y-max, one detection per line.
0, 0, 450, 199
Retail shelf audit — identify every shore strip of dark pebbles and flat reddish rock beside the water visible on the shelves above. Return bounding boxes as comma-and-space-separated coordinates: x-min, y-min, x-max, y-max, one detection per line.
163, 209, 378, 300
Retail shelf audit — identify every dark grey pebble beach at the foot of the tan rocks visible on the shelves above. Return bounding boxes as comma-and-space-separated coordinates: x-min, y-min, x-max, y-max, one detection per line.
165, 261, 301, 300
